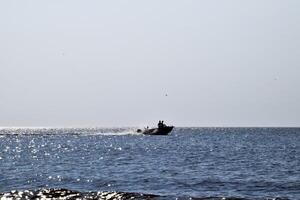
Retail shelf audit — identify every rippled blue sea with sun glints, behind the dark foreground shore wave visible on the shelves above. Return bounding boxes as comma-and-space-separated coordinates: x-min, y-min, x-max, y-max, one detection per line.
0, 128, 300, 200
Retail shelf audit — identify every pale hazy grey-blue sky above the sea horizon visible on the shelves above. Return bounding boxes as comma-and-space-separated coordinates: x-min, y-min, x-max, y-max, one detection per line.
0, 0, 300, 127
